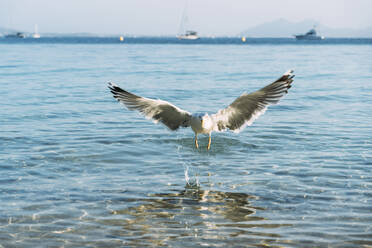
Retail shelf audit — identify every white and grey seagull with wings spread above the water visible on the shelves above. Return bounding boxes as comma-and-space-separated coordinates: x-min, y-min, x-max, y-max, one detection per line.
108, 70, 294, 150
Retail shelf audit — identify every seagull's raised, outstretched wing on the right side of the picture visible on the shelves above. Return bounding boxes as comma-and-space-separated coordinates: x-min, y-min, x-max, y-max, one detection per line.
212, 70, 294, 132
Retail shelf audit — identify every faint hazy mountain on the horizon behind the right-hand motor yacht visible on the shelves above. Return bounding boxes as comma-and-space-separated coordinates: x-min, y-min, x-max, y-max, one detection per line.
238, 19, 372, 38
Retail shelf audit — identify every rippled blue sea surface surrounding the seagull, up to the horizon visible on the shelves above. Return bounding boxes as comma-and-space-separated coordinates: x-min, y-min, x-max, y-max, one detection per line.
0, 37, 372, 247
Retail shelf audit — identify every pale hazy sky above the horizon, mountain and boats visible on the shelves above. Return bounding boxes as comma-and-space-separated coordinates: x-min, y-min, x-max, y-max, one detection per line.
0, 0, 372, 35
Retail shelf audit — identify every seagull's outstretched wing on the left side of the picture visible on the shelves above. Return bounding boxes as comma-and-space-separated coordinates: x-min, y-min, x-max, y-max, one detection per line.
108, 83, 191, 131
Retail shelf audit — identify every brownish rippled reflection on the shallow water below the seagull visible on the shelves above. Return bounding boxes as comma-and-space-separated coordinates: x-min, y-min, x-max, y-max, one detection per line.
101, 185, 290, 246
